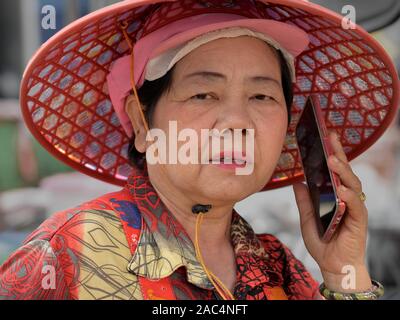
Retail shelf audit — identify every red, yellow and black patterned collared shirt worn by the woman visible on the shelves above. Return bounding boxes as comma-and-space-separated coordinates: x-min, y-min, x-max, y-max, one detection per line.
0, 172, 319, 300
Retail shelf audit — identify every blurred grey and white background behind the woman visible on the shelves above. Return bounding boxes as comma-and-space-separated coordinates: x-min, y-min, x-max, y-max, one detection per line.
0, 0, 400, 299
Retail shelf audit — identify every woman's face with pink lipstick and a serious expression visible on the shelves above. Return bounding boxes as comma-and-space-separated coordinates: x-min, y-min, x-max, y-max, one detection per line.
147, 36, 287, 204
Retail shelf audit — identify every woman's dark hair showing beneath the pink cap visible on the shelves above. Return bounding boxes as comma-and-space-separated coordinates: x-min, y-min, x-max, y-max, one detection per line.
128, 50, 293, 170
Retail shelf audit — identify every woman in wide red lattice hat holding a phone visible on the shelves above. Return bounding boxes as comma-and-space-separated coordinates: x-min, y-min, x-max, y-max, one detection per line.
0, 0, 397, 300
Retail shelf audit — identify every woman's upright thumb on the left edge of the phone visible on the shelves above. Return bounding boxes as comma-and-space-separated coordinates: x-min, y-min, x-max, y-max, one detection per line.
293, 182, 319, 240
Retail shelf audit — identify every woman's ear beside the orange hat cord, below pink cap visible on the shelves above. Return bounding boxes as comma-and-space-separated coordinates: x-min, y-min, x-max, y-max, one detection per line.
125, 95, 147, 153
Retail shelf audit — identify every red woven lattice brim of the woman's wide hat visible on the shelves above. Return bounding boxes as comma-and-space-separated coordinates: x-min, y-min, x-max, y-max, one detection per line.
21, 0, 396, 189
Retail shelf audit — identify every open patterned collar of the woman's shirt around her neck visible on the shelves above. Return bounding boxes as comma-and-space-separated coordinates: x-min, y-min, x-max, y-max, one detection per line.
126, 172, 267, 289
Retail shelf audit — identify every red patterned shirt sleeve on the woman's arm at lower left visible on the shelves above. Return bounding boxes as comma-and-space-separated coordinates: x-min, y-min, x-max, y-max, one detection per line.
0, 239, 71, 300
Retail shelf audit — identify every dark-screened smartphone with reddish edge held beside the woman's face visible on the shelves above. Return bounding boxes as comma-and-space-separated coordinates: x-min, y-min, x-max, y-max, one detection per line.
295, 95, 346, 242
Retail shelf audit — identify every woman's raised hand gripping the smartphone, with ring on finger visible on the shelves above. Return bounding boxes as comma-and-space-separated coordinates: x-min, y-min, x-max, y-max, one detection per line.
293, 132, 372, 292
